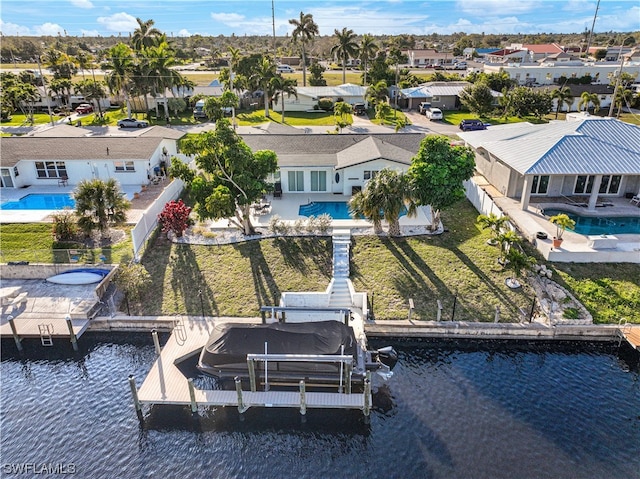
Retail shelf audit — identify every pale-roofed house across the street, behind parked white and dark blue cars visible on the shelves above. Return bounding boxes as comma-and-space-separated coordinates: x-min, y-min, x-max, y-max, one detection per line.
398, 81, 502, 110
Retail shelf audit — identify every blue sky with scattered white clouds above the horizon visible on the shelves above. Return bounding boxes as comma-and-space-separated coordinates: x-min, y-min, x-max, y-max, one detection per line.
0, 0, 640, 37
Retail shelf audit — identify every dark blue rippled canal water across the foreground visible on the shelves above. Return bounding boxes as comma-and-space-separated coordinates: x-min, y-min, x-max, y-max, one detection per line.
0, 335, 640, 479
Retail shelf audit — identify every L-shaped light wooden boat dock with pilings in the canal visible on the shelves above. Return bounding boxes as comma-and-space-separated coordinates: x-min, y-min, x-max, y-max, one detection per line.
129, 317, 371, 416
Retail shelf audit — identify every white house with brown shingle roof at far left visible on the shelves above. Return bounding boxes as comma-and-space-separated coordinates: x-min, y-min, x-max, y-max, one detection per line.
0, 125, 184, 188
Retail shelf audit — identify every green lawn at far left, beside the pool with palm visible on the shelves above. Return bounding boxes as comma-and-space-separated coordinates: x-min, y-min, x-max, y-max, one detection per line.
0, 223, 133, 263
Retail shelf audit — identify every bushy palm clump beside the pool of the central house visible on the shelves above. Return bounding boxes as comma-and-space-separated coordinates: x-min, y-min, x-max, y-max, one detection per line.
349, 168, 416, 236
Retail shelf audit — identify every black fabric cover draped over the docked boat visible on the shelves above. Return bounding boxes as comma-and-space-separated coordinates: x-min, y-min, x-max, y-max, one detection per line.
198, 321, 357, 377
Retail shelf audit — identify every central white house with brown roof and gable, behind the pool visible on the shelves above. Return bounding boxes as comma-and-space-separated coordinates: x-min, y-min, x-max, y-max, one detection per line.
243, 133, 424, 196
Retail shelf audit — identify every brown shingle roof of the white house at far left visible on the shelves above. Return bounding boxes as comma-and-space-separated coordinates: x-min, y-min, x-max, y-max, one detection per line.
0, 136, 162, 167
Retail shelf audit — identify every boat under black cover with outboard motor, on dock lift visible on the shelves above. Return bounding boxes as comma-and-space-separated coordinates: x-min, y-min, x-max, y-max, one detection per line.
198, 320, 395, 384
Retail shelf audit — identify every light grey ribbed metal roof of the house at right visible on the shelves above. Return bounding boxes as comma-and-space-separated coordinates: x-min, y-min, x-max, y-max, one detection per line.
459, 118, 640, 175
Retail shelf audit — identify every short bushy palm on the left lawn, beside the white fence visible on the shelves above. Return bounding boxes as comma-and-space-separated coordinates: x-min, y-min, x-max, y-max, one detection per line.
73, 178, 131, 235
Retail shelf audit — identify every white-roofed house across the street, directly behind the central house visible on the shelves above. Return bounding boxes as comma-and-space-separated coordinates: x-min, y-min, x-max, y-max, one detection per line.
273, 83, 368, 111
